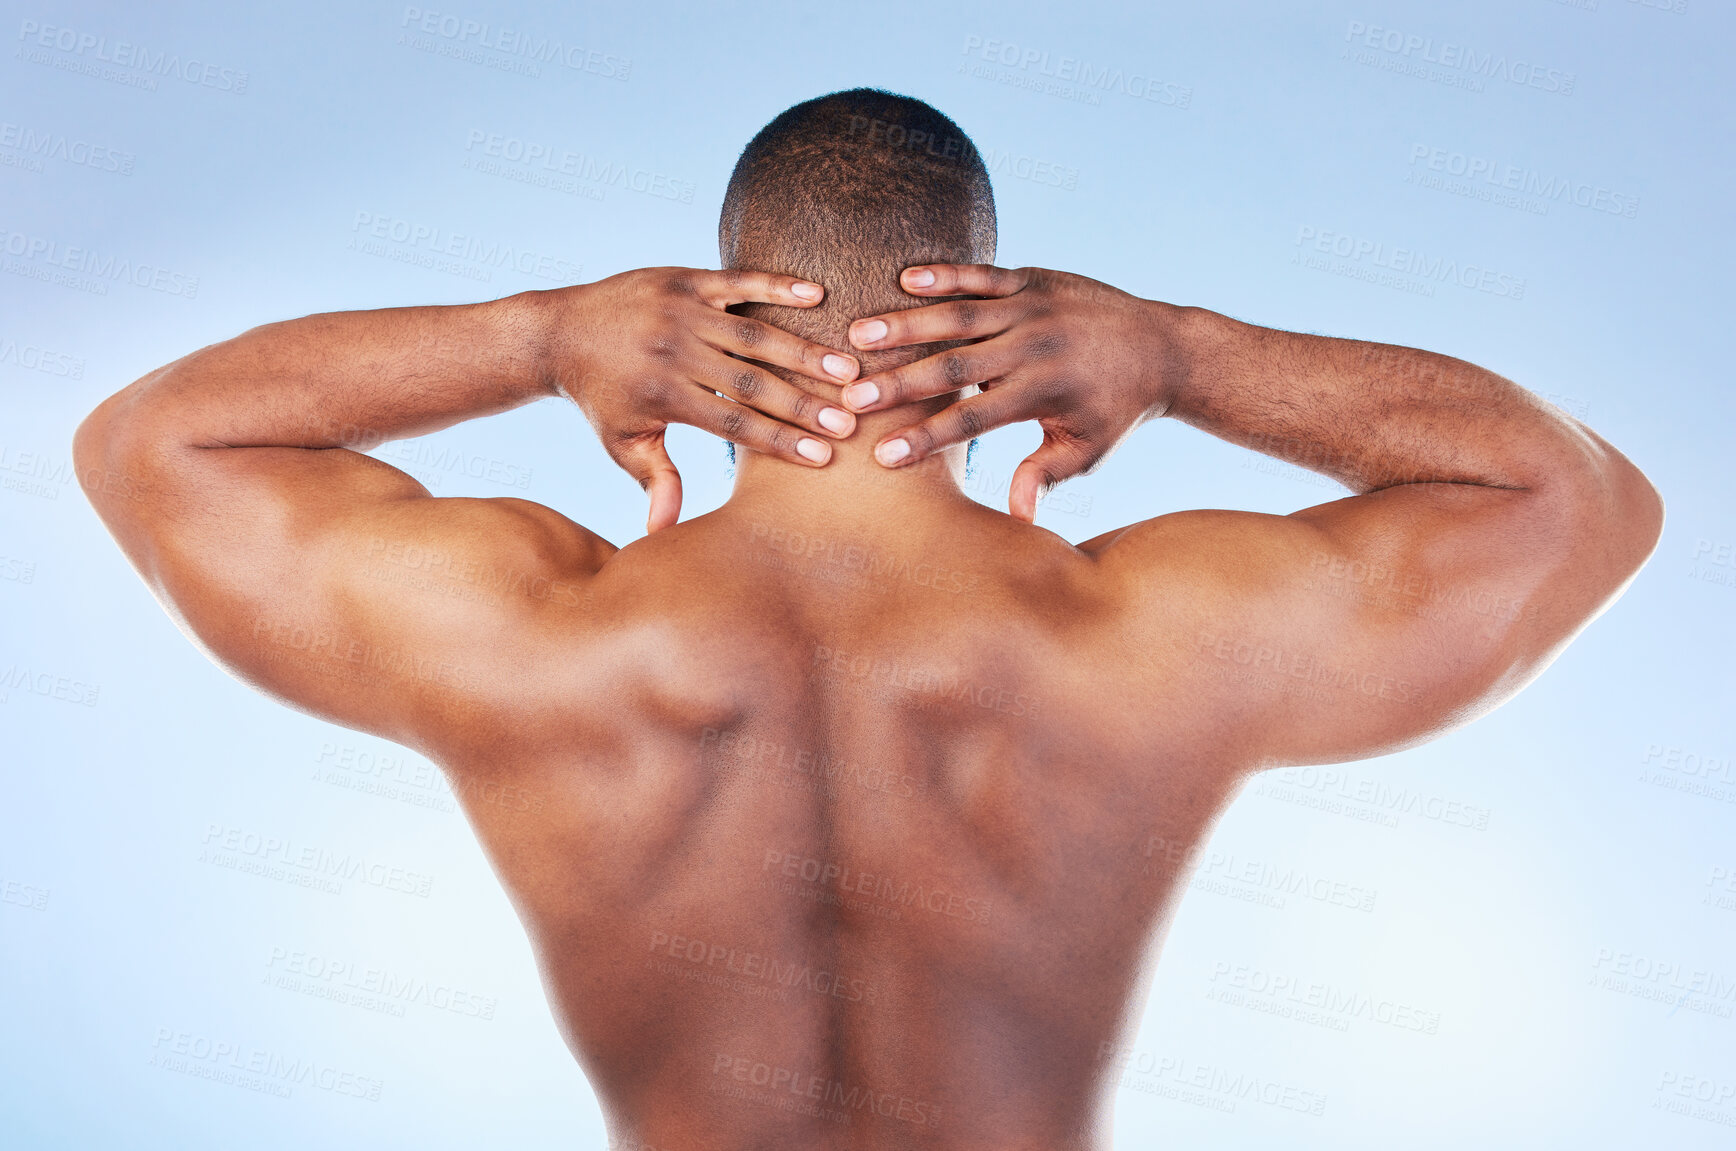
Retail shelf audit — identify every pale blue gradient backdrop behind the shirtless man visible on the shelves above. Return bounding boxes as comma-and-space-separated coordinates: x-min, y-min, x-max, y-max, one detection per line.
0, 0, 1736, 1151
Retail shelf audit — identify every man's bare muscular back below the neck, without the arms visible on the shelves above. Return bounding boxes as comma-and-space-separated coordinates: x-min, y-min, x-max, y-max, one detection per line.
450, 509, 1231, 1151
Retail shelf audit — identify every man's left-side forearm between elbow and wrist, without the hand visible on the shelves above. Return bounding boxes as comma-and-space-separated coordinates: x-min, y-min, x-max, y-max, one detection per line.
80, 293, 557, 465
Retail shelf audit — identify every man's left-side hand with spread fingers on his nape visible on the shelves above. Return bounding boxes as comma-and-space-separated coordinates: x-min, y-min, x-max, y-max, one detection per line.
549, 267, 858, 531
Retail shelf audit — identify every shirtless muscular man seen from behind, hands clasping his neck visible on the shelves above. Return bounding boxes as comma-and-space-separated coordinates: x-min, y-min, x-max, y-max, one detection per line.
76, 92, 1663, 1151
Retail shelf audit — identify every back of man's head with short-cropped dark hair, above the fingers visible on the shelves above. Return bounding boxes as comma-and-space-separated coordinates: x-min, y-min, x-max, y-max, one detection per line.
717, 89, 995, 373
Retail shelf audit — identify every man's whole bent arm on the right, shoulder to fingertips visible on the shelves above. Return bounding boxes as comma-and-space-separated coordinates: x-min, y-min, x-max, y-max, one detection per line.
845, 266, 1663, 766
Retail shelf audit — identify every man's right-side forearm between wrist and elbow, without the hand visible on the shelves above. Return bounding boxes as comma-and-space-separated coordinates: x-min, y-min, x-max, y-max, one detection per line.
1156, 304, 1604, 491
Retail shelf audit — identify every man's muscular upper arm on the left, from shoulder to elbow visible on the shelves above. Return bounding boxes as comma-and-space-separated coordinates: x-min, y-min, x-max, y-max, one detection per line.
81, 437, 613, 745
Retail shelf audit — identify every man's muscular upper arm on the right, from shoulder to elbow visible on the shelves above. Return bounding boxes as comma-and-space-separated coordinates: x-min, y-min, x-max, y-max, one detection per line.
1097, 483, 1649, 766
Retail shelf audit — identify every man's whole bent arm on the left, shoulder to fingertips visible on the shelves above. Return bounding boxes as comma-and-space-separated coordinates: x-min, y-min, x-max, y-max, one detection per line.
75, 269, 854, 750
